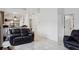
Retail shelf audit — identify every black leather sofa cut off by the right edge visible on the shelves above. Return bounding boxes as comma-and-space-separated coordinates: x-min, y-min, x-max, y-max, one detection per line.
63, 30, 79, 50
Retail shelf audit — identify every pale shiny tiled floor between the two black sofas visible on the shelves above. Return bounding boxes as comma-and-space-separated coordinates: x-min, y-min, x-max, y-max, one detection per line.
14, 32, 67, 50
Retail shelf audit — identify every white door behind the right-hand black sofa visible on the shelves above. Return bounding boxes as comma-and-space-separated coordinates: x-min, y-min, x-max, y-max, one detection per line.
64, 14, 74, 35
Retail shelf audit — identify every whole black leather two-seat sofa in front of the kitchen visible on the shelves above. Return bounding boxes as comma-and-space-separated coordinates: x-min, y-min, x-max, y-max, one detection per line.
9, 28, 34, 46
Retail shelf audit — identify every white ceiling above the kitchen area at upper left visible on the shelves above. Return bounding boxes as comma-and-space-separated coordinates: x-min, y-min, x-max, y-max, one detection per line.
0, 8, 39, 18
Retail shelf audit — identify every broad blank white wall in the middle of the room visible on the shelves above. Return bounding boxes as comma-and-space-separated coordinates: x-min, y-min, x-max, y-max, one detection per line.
37, 8, 58, 42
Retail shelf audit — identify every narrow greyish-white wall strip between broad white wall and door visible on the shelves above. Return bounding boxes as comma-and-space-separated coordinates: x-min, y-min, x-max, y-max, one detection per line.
58, 8, 64, 44
